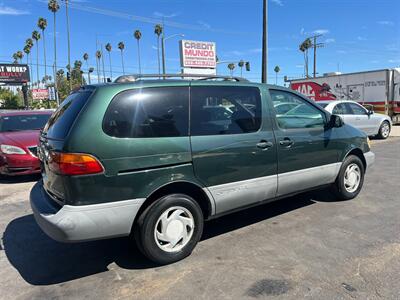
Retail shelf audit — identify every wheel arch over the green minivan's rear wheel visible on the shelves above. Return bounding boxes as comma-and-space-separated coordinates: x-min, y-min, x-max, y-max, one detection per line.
133, 181, 215, 225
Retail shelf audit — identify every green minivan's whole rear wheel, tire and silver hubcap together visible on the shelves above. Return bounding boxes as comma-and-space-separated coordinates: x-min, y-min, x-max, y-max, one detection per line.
134, 194, 204, 265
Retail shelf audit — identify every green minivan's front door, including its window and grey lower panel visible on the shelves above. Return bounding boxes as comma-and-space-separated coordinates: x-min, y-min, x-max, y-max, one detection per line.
269, 89, 340, 196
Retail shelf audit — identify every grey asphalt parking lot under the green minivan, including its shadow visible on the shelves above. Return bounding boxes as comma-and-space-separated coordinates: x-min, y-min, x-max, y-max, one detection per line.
0, 138, 400, 299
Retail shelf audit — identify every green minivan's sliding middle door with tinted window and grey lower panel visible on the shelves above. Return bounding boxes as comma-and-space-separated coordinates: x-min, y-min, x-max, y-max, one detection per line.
190, 82, 277, 213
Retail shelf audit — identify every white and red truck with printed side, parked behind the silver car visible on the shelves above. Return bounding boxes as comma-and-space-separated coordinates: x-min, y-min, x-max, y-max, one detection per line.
285, 68, 400, 124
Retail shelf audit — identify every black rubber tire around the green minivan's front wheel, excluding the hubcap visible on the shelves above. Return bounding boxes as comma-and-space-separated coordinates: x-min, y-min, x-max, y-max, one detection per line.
333, 155, 365, 200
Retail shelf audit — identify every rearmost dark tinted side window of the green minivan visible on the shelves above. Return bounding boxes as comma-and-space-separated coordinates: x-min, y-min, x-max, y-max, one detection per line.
103, 87, 189, 138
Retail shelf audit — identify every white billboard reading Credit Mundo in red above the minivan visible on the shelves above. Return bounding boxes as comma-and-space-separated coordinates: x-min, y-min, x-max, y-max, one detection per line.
179, 40, 217, 69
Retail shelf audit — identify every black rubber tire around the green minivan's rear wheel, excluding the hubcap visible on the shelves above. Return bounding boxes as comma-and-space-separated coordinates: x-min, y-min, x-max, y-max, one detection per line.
134, 194, 204, 265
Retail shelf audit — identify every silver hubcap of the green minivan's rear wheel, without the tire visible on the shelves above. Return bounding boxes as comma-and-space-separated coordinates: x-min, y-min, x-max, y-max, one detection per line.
154, 206, 194, 252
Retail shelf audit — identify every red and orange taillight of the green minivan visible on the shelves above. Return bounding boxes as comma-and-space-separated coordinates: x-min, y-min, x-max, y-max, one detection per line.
49, 152, 104, 175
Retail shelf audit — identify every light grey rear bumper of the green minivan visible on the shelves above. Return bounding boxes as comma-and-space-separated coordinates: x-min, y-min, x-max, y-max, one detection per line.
30, 181, 145, 242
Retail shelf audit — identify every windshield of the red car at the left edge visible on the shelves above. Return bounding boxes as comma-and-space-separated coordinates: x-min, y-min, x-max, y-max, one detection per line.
0, 114, 50, 132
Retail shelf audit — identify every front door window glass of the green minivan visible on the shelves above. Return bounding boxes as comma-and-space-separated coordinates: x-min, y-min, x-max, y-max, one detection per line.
269, 90, 325, 129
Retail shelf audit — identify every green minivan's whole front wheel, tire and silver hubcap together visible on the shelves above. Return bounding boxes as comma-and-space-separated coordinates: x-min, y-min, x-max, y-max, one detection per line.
333, 155, 365, 200
